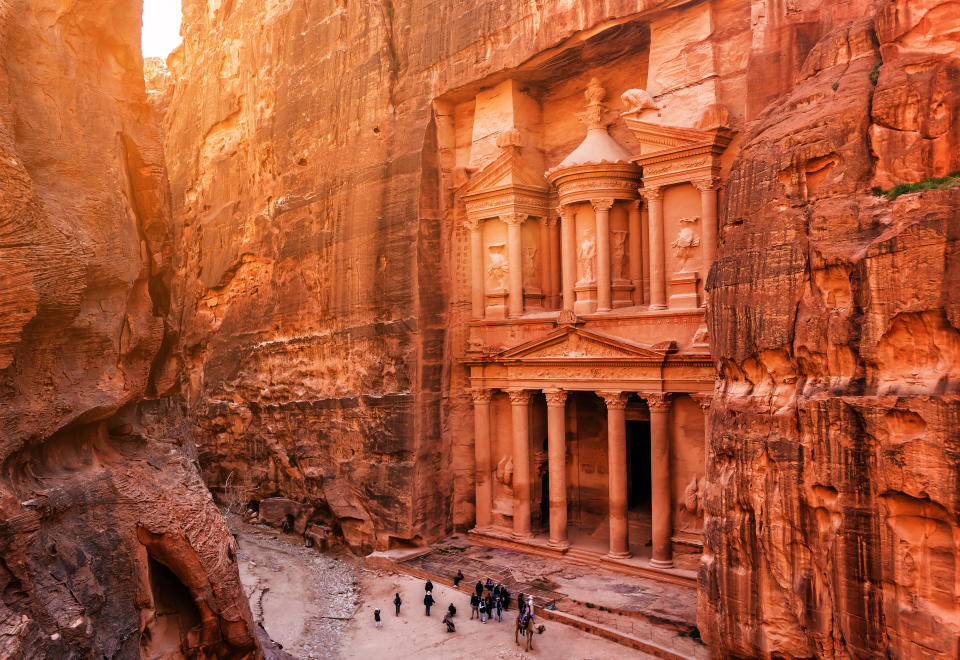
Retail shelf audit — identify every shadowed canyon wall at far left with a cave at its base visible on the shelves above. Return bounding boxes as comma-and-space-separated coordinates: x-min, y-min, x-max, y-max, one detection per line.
0, 0, 260, 658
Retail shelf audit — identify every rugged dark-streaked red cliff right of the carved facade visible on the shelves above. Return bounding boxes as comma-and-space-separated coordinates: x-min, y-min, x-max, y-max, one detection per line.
700, 0, 960, 658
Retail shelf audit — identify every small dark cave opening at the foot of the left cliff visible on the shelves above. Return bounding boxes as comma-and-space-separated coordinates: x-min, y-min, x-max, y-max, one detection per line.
140, 557, 201, 658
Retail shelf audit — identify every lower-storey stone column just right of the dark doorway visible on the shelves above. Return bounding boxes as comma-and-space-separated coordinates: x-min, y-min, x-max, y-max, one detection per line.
643, 392, 673, 568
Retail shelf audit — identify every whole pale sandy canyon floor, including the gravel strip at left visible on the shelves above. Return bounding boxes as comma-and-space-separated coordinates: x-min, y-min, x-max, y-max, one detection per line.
231, 521, 652, 660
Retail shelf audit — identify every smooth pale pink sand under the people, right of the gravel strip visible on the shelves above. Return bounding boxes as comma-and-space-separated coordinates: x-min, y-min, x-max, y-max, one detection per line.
339, 570, 652, 660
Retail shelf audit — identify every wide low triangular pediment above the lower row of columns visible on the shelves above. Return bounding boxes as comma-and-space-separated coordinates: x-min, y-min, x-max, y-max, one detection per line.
494, 326, 666, 361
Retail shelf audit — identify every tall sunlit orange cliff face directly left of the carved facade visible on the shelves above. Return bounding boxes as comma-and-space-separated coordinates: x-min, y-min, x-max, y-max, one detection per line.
165, 0, 682, 550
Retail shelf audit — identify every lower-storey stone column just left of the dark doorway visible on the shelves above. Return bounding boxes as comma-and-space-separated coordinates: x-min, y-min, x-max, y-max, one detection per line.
597, 392, 630, 559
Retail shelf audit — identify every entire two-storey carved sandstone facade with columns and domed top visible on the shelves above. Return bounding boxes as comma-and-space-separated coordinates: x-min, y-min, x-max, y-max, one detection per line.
455, 69, 732, 569
